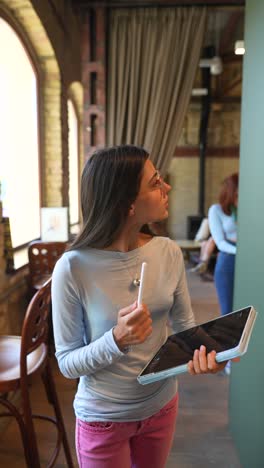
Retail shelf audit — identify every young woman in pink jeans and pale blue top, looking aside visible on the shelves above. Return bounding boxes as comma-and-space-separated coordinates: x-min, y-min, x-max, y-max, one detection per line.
52, 145, 227, 468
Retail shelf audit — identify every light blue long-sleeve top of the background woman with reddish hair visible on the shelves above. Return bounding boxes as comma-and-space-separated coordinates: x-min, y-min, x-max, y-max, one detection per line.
208, 204, 237, 254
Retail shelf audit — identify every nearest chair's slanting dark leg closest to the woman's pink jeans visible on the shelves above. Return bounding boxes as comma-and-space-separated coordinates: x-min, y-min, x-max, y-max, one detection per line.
42, 360, 74, 468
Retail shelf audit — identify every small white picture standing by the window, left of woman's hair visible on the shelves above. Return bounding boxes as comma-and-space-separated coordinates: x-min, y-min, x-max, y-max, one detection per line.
41, 207, 69, 242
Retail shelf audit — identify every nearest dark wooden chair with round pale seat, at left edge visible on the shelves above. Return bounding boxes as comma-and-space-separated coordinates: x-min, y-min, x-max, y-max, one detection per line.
0, 280, 74, 468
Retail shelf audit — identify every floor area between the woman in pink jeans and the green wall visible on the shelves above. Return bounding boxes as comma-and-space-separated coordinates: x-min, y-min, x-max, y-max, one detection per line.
166, 273, 241, 468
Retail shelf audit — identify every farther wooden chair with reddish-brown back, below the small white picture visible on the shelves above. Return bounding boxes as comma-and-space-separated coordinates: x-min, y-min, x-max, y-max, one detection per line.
28, 241, 67, 297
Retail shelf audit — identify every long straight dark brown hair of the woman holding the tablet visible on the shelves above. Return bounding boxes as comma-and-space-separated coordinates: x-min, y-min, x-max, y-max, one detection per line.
70, 145, 149, 250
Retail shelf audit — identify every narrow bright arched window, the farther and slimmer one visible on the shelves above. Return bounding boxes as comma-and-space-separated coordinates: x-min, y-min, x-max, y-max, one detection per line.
68, 99, 79, 226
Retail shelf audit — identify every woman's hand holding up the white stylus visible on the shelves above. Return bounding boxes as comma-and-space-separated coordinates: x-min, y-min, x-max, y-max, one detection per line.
113, 301, 152, 351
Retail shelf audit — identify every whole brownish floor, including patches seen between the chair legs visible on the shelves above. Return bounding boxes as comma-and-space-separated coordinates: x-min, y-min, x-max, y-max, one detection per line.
0, 268, 241, 468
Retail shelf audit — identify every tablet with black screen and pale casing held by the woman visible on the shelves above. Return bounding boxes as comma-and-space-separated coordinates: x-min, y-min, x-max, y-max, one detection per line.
138, 306, 256, 384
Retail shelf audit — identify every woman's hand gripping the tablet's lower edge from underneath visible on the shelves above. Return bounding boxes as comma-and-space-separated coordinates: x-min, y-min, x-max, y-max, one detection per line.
188, 346, 239, 375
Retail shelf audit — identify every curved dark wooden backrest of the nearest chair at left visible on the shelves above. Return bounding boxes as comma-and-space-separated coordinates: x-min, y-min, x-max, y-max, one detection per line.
20, 279, 51, 372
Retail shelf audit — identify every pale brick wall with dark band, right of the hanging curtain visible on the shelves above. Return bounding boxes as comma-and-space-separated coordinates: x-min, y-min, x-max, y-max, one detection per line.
168, 102, 240, 239
